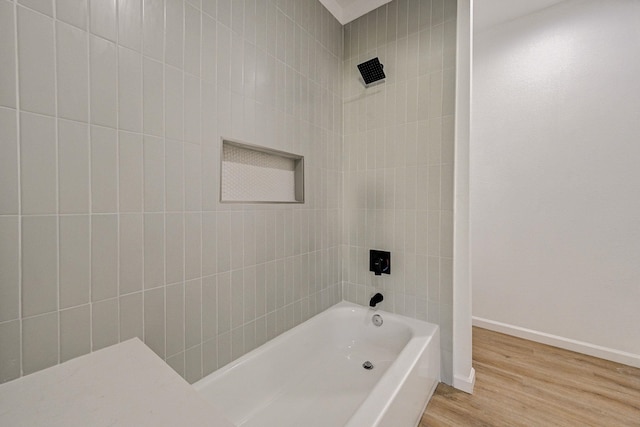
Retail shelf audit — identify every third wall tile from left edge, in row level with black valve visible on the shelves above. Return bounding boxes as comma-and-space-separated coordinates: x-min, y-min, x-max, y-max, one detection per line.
60, 215, 91, 308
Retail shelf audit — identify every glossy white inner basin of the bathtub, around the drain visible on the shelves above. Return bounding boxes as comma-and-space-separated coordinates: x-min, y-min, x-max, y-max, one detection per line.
194, 303, 440, 427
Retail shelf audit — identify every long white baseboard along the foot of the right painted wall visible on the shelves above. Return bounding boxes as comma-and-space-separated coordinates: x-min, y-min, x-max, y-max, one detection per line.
473, 316, 640, 368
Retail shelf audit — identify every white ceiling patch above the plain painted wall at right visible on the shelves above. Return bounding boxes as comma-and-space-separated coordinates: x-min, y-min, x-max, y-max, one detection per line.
473, 0, 564, 31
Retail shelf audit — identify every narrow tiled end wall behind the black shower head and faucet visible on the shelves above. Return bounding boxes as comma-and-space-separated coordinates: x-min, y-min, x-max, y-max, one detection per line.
343, 0, 456, 383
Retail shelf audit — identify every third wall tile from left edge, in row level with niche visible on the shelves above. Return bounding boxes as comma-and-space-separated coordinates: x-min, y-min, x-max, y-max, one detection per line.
58, 120, 90, 213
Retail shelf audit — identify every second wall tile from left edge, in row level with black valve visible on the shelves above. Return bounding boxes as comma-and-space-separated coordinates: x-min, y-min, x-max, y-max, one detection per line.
22, 216, 58, 317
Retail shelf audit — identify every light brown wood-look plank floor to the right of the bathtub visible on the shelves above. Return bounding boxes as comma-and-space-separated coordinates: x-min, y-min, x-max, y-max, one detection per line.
419, 328, 640, 427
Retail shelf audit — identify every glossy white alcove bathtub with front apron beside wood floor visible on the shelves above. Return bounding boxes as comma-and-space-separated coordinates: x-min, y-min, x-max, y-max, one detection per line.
194, 302, 440, 427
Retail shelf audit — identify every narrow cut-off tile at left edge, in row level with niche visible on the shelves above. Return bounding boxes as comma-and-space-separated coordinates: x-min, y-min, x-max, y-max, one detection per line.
0, 108, 19, 215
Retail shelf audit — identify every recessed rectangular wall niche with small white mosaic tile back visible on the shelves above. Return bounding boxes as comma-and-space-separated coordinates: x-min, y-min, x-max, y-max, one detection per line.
220, 139, 304, 203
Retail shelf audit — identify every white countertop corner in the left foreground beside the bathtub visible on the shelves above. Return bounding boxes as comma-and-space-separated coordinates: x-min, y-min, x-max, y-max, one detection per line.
0, 338, 233, 427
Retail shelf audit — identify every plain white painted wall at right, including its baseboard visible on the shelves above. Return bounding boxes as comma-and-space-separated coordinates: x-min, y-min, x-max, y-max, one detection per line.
470, 0, 640, 366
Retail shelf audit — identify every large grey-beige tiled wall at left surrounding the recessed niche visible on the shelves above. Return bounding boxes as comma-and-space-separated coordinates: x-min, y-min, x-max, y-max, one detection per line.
0, 0, 343, 382
